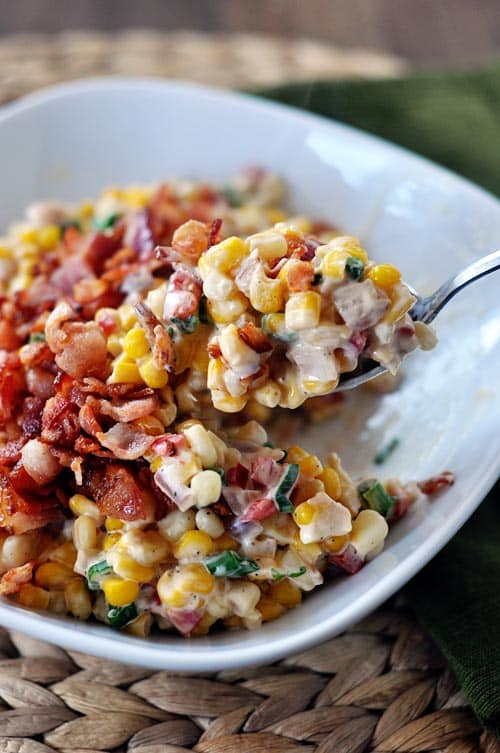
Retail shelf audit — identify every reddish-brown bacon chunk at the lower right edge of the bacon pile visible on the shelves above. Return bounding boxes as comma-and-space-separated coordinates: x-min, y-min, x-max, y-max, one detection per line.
82, 463, 148, 521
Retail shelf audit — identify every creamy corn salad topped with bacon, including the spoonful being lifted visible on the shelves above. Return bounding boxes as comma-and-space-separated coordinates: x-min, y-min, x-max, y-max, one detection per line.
0, 168, 453, 636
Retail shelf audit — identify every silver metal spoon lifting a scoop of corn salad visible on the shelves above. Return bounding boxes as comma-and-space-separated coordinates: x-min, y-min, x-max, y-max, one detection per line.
336, 250, 500, 391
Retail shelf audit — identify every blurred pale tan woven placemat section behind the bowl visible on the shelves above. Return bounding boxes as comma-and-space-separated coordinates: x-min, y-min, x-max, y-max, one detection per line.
0, 30, 407, 102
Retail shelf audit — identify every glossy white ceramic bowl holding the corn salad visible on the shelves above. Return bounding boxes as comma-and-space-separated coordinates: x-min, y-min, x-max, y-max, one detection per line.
0, 79, 500, 671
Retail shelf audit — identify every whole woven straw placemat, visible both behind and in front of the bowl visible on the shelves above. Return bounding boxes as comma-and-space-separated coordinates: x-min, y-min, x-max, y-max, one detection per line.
0, 31, 490, 753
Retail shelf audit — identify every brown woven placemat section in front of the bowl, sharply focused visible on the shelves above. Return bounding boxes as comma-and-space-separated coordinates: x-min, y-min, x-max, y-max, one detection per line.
0, 607, 500, 753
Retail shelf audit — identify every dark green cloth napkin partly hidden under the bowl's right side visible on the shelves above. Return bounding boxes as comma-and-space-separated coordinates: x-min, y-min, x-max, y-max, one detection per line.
258, 63, 500, 737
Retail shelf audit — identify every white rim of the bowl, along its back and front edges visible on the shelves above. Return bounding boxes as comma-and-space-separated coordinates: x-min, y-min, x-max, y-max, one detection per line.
0, 76, 500, 672
